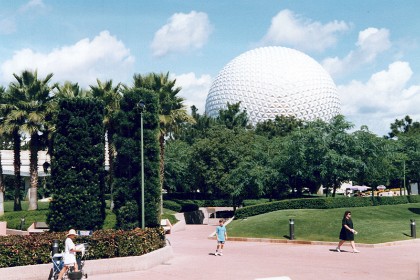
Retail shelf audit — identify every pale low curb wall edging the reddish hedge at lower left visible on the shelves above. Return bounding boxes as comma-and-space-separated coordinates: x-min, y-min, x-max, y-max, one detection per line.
0, 246, 173, 280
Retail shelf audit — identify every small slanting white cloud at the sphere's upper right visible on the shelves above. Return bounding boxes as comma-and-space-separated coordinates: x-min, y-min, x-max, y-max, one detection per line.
322, 27, 391, 76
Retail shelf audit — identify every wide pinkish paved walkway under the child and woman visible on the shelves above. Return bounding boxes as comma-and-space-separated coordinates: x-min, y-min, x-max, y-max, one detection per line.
88, 219, 420, 280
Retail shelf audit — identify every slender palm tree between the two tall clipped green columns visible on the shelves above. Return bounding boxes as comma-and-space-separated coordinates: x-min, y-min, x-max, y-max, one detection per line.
90, 79, 122, 210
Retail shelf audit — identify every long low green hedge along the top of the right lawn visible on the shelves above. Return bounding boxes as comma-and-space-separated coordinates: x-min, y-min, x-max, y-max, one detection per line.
235, 195, 420, 219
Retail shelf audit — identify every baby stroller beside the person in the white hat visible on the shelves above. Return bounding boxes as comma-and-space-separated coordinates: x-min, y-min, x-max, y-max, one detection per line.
48, 242, 89, 280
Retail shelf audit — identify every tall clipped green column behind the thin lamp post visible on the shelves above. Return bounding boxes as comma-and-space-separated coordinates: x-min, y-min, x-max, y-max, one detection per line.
114, 89, 161, 228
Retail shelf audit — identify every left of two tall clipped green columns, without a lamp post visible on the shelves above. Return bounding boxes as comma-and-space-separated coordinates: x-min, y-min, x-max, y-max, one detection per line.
47, 98, 105, 231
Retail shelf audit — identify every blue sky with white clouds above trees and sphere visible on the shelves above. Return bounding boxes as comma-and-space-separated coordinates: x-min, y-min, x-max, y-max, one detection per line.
0, 0, 420, 135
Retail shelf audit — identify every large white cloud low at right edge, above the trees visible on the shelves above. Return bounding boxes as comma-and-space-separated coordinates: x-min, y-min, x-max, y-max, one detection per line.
338, 61, 420, 135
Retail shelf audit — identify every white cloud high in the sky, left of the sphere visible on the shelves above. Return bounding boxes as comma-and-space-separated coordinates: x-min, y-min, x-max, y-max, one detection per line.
151, 11, 213, 56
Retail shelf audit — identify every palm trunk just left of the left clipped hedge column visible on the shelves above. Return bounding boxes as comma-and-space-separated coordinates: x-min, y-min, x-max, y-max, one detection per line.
28, 133, 38, 210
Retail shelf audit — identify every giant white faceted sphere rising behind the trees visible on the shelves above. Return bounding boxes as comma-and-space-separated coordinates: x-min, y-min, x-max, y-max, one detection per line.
206, 47, 340, 125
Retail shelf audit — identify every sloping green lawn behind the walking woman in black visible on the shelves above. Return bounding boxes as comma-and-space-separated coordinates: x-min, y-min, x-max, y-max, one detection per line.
227, 203, 420, 244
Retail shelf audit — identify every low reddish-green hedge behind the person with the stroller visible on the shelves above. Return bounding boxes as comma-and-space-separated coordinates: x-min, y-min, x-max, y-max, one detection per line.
0, 228, 165, 268
